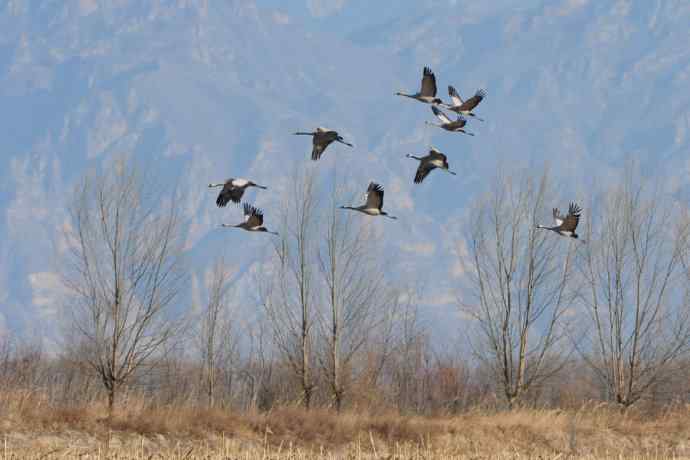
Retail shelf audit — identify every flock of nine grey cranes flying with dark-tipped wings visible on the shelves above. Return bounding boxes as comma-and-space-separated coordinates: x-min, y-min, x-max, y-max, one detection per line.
208, 67, 582, 243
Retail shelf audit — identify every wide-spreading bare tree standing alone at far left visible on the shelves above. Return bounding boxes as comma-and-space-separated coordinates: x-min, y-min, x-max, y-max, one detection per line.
64, 161, 183, 416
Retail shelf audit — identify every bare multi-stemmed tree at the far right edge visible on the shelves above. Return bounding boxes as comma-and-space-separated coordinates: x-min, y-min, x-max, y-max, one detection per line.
578, 177, 690, 406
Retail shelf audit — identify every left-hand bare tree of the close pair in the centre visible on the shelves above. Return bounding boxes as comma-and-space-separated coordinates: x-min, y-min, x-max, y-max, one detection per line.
260, 174, 318, 408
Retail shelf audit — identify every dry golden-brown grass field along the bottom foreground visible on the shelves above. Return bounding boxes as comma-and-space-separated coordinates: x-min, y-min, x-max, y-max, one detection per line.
0, 394, 690, 460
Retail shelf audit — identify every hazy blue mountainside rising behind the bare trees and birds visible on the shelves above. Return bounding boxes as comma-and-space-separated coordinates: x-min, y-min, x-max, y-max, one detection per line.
0, 0, 690, 342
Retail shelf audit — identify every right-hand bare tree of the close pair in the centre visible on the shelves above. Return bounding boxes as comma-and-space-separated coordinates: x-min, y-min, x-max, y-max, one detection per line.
318, 189, 392, 412
